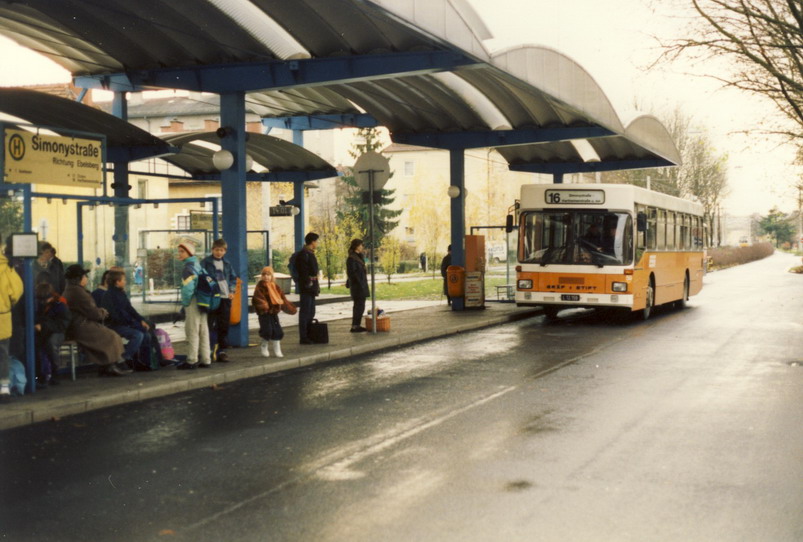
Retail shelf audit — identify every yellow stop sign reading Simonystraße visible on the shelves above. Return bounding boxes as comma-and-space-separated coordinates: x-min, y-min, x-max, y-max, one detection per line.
3, 128, 103, 188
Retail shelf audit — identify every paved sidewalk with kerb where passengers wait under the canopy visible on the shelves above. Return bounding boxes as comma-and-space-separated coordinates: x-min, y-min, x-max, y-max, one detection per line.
0, 301, 540, 429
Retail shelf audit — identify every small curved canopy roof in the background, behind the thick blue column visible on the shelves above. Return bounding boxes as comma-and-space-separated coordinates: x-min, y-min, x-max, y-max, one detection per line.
162, 132, 337, 181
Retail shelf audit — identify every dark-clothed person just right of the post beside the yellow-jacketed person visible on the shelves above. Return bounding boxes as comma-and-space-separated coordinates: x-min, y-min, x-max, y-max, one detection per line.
34, 282, 71, 388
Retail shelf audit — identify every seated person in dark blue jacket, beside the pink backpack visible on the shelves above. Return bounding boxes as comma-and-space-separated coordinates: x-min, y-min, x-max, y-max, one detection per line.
102, 270, 151, 370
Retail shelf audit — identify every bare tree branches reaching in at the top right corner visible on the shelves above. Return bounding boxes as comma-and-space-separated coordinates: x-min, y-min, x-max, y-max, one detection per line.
666, 0, 803, 139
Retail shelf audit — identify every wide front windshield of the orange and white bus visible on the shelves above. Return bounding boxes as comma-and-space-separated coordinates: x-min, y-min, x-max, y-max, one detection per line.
519, 210, 633, 267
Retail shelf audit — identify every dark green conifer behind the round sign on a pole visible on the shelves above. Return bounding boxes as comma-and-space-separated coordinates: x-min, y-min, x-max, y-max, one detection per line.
337, 128, 402, 249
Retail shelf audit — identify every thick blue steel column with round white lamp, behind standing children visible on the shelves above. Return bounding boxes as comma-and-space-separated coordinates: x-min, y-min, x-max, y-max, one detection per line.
220, 91, 248, 346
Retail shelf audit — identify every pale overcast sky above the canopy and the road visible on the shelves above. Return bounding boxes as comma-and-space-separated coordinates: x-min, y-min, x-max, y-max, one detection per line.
0, 0, 803, 215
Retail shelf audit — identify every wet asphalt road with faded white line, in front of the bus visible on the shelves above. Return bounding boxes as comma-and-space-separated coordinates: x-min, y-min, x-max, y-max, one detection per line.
0, 255, 803, 542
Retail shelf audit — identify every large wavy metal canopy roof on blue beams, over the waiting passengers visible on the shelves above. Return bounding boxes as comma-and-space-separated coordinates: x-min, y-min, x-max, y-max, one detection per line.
0, 0, 679, 172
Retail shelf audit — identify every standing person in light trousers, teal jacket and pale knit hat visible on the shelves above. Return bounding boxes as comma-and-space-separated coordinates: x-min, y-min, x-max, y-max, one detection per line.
177, 242, 210, 369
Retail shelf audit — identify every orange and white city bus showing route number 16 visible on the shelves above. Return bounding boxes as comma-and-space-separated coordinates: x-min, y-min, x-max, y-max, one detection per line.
508, 184, 706, 320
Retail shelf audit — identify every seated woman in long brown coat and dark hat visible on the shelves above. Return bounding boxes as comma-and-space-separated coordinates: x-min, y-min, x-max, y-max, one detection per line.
64, 265, 131, 376
